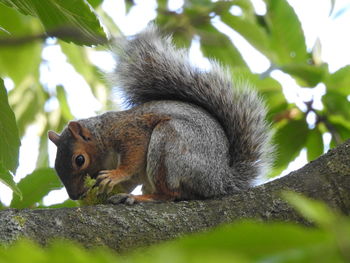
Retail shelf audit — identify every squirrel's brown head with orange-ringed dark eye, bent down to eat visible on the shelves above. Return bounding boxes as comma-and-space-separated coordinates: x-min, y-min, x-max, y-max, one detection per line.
48, 121, 101, 200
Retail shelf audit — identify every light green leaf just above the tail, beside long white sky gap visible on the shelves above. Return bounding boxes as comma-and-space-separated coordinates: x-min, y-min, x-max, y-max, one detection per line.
198, 25, 247, 67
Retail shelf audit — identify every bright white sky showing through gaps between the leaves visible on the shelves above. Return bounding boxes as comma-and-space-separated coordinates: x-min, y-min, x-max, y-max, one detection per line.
0, 0, 350, 205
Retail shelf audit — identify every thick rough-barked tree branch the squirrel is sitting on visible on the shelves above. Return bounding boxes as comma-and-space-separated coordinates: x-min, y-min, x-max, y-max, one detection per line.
0, 141, 350, 251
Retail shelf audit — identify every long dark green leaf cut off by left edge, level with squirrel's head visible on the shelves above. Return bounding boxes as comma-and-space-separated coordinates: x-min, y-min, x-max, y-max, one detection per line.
0, 79, 21, 173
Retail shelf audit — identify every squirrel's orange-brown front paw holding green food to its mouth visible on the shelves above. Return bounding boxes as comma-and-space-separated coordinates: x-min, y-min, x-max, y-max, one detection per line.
94, 170, 129, 194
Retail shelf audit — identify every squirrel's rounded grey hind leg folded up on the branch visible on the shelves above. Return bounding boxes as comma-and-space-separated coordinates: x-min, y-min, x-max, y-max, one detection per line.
147, 119, 230, 200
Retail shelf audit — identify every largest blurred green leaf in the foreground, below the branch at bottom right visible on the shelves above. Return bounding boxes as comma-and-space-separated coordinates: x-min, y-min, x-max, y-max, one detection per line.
135, 221, 339, 263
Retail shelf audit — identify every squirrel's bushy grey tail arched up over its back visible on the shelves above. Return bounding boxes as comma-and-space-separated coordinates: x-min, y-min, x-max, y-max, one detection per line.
114, 26, 271, 179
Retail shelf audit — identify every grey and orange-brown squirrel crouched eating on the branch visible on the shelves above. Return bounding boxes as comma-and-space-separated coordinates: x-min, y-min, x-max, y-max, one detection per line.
48, 25, 273, 203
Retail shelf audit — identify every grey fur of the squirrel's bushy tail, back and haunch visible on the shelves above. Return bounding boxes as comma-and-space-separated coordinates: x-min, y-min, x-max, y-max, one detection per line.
112, 26, 272, 198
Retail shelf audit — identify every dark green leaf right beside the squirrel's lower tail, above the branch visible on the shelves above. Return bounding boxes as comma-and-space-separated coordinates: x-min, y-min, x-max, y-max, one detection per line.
274, 119, 309, 175
